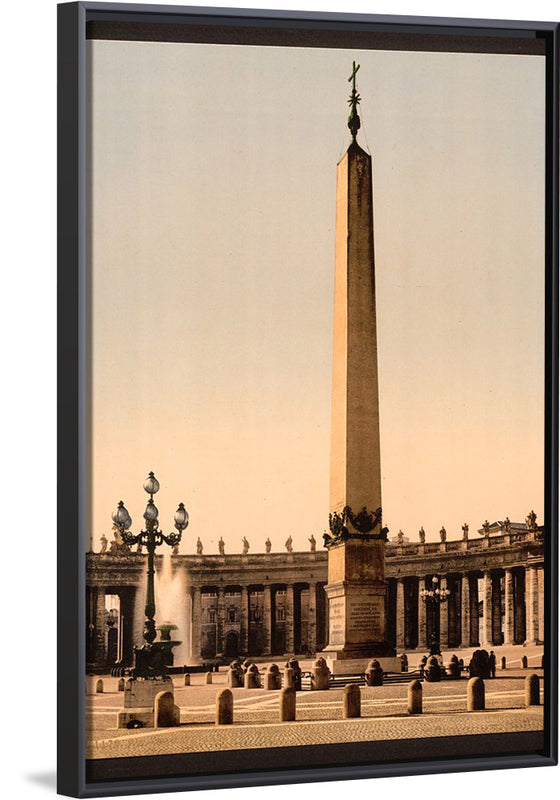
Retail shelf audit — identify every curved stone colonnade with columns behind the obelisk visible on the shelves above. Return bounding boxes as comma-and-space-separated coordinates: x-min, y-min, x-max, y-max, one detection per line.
86, 523, 544, 672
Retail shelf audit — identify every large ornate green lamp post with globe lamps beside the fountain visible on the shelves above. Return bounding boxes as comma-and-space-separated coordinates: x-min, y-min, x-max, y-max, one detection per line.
113, 472, 189, 677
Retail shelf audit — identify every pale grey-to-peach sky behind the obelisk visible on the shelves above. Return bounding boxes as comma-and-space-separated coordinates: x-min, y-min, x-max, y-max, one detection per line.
88, 41, 545, 553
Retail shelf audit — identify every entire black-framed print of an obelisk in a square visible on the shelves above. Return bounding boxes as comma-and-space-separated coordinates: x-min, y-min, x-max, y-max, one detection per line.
58, 2, 558, 797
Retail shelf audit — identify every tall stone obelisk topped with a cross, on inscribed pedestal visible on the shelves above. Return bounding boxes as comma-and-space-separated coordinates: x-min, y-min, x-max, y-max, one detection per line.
324, 63, 396, 674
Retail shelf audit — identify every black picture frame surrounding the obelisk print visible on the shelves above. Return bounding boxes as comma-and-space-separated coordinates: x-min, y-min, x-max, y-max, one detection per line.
58, 2, 559, 797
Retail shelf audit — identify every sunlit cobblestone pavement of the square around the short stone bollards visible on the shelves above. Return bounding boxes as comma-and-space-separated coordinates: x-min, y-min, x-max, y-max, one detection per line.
86, 670, 543, 758
